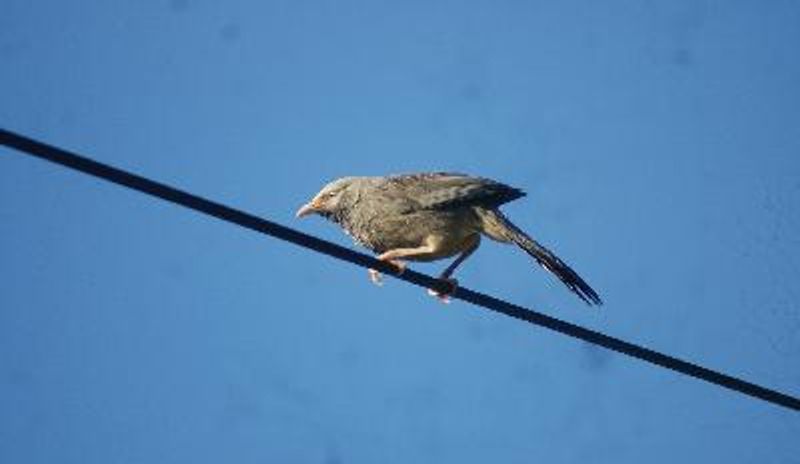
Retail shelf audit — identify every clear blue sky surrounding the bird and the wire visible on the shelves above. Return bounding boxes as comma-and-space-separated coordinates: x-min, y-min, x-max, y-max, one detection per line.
0, 0, 800, 464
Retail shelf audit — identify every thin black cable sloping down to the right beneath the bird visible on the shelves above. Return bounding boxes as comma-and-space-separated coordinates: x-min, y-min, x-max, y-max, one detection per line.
0, 129, 800, 411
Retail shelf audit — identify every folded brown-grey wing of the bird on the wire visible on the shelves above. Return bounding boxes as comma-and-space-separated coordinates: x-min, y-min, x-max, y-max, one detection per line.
386, 172, 525, 210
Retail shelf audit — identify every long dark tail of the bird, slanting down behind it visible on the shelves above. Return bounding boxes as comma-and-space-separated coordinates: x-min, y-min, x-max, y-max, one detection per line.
476, 208, 603, 305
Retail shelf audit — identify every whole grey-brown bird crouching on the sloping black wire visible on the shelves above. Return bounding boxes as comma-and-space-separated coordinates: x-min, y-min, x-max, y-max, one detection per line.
297, 173, 602, 305
